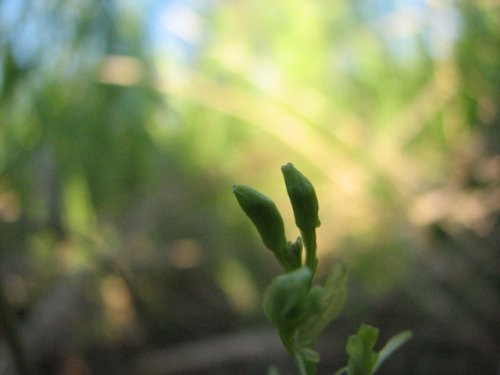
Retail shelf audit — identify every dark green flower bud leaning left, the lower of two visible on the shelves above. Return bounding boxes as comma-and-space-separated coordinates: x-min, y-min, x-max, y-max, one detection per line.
233, 185, 287, 258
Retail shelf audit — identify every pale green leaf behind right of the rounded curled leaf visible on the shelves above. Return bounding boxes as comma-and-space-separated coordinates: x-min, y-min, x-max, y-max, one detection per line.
299, 264, 347, 345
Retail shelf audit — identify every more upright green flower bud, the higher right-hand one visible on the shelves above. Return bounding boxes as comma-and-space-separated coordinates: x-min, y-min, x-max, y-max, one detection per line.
281, 163, 321, 231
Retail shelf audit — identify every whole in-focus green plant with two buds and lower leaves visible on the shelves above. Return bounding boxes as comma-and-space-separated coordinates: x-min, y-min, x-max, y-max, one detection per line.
233, 163, 411, 375
